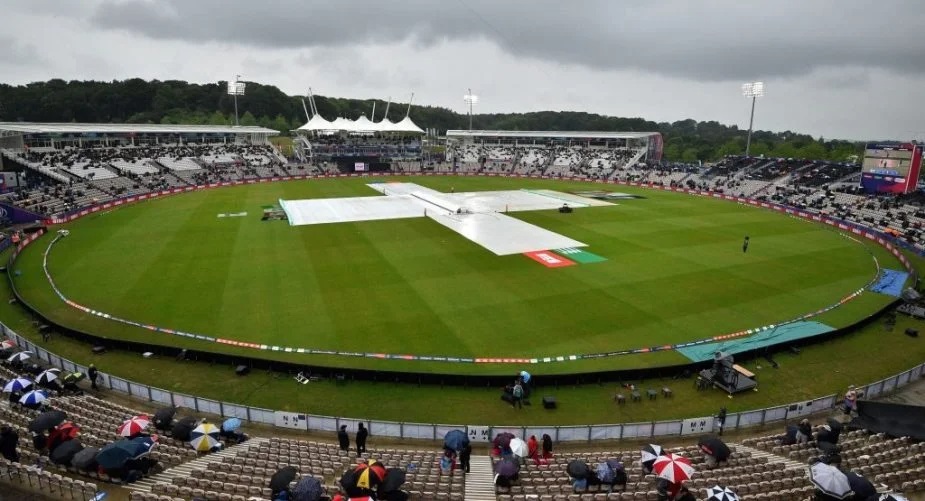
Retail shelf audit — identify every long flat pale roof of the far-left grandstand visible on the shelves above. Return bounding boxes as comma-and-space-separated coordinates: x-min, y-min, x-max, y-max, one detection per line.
0, 122, 279, 136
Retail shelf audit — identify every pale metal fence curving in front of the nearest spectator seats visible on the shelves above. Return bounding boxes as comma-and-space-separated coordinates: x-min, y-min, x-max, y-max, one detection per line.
0, 323, 925, 442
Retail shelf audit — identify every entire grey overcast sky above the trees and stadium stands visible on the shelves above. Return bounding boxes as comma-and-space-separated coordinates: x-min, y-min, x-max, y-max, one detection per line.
0, 0, 925, 140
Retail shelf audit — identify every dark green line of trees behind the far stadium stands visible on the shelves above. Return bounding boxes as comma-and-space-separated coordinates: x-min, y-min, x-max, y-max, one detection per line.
0, 78, 863, 162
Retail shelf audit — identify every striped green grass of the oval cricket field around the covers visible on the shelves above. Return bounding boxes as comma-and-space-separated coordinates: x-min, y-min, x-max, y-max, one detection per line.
7, 177, 899, 374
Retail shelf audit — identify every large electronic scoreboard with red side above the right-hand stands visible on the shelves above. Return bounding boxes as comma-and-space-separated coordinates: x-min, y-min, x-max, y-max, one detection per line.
861, 143, 922, 193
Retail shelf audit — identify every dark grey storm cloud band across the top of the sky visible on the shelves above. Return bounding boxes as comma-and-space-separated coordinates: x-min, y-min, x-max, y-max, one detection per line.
91, 0, 925, 81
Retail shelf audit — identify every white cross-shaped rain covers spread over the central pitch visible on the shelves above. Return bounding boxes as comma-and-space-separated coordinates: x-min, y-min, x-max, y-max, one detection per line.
279, 183, 613, 256
